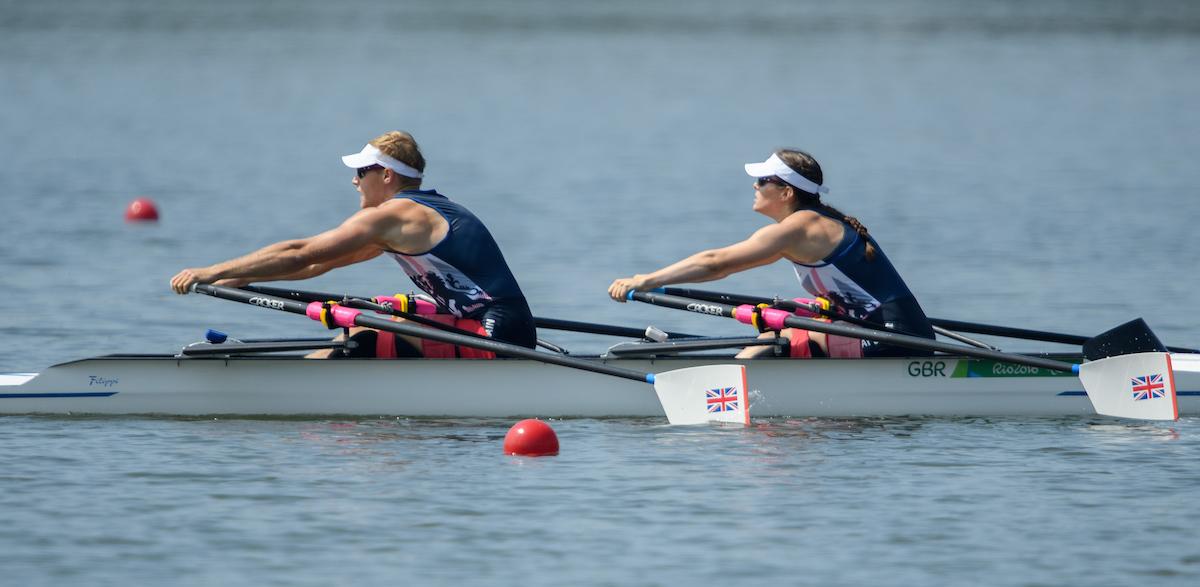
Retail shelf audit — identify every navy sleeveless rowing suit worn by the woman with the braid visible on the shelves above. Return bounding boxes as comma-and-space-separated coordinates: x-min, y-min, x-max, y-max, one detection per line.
792, 209, 934, 357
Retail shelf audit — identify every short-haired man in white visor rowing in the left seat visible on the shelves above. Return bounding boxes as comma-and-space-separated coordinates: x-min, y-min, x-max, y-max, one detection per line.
170, 131, 536, 358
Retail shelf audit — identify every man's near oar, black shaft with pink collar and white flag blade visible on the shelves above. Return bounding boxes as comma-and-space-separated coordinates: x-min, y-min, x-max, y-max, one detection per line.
192, 283, 750, 425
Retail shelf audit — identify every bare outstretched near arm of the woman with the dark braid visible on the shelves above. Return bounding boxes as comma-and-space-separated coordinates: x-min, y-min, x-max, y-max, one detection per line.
608, 223, 803, 301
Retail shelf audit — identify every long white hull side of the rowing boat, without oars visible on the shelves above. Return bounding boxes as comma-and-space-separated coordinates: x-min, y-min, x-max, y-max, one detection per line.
0, 355, 1200, 418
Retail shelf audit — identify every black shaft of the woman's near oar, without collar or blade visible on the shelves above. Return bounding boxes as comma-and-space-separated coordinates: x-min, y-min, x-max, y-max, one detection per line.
630, 292, 1075, 372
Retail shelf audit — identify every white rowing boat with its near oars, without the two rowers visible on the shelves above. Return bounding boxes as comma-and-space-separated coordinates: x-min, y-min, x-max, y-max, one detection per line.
7, 284, 1200, 424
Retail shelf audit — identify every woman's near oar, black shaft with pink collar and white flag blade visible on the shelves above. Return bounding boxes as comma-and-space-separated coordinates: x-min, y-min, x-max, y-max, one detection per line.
629, 292, 1200, 420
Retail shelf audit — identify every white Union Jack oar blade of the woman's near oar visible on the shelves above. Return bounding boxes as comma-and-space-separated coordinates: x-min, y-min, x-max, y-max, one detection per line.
1079, 353, 1180, 420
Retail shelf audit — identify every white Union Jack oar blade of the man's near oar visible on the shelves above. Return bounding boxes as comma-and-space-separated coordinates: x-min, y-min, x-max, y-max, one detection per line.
654, 365, 750, 425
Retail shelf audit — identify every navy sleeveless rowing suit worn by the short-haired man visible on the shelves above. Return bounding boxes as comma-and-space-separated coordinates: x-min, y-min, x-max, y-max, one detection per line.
386, 190, 538, 348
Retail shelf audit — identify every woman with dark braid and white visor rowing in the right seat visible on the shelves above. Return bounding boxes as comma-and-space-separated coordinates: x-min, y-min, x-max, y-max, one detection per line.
608, 149, 934, 358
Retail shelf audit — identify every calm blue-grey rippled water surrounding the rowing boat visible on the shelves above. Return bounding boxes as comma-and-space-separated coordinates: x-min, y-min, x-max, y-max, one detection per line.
0, 0, 1200, 585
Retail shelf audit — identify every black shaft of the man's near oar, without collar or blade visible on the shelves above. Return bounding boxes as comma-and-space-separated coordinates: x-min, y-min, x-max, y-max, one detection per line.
194, 283, 654, 383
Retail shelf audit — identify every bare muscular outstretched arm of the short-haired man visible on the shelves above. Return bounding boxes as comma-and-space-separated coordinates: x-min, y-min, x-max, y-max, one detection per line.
170, 209, 403, 293
